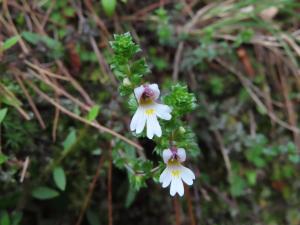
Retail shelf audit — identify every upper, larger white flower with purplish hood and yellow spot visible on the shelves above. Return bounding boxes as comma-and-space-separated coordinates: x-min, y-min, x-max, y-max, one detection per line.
130, 84, 172, 139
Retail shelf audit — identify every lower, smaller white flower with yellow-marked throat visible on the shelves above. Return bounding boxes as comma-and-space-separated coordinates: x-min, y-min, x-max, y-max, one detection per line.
159, 148, 195, 196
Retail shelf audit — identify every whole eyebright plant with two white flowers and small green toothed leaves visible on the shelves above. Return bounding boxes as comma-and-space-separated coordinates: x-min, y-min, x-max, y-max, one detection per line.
110, 33, 199, 196
